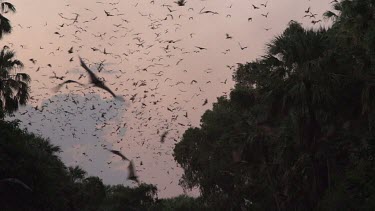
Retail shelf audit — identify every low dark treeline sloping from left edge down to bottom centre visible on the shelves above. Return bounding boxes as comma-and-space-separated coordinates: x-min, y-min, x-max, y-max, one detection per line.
0, 120, 206, 211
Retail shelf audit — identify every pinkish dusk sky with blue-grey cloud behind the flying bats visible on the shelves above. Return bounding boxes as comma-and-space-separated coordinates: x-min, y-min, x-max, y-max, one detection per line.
0, 0, 331, 198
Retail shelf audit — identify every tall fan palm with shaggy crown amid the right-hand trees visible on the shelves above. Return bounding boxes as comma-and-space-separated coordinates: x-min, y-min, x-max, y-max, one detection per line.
264, 21, 332, 148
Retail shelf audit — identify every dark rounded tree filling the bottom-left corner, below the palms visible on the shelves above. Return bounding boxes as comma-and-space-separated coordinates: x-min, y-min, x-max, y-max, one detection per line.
0, 121, 71, 210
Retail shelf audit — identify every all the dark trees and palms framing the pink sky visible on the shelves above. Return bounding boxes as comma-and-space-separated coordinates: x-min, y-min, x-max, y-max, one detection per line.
0, 0, 375, 211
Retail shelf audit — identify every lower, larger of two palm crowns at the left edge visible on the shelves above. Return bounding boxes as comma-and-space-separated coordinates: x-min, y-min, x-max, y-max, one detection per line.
0, 46, 30, 119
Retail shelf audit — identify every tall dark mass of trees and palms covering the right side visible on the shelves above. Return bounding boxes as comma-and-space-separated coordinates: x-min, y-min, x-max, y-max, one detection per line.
174, 0, 375, 210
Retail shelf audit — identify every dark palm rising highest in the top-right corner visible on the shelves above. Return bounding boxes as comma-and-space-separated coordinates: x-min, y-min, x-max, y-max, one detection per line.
325, 0, 375, 114
